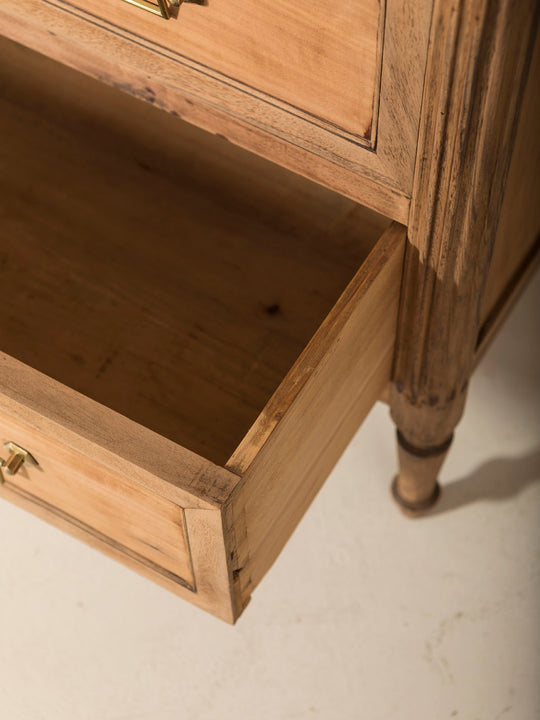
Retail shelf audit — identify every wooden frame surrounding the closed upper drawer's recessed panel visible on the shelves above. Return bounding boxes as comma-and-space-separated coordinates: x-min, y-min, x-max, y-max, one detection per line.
0, 0, 431, 222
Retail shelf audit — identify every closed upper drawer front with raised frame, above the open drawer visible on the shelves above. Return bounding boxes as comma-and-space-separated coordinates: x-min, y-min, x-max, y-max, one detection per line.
0, 0, 432, 222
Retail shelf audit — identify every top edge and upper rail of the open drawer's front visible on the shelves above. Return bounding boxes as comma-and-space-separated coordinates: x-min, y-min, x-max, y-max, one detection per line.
0, 353, 238, 509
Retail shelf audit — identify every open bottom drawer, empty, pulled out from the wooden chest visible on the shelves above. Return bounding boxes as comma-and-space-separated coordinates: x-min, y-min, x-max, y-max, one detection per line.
0, 43, 404, 622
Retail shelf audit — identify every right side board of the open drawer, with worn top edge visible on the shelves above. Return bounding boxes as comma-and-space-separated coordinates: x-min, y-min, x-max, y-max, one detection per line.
225, 225, 405, 608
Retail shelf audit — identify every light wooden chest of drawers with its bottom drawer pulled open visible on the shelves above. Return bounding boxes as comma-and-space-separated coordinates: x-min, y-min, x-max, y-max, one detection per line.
0, 0, 539, 622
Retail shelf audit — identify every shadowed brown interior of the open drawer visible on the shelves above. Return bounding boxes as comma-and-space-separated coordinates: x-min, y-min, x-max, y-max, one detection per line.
0, 41, 389, 464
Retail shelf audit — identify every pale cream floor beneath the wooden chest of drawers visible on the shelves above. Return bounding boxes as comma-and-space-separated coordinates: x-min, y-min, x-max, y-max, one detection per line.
0, 278, 540, 720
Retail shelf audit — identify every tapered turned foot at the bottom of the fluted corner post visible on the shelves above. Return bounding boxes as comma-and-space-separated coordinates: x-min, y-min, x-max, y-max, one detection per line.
392, 430, 453, 517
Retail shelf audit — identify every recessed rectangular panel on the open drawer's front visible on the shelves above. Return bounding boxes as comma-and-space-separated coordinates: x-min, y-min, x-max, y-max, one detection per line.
0, 410, 194, 589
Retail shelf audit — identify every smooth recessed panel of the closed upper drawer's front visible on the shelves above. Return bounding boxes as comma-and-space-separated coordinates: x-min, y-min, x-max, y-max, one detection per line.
73, 0, 384, 143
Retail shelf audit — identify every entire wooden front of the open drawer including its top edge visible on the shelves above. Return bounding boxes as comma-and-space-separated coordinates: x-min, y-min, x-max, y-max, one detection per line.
0, 354, 238, 622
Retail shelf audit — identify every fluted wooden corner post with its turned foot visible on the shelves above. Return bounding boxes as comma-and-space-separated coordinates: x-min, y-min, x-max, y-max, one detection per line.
390, 0, 539, 515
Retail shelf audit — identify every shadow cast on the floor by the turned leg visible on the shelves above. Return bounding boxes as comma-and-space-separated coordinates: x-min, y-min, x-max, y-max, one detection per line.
424, 448, 540, 517
